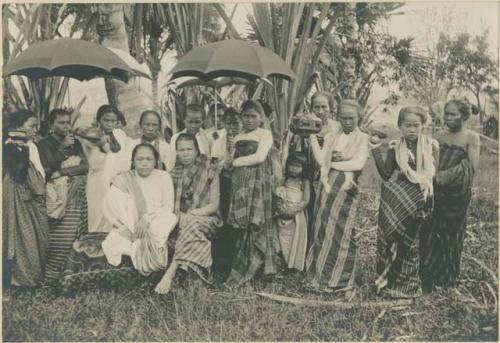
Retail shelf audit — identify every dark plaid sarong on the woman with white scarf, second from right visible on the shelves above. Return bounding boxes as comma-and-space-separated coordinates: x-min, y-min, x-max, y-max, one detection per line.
375, 176, 425, 298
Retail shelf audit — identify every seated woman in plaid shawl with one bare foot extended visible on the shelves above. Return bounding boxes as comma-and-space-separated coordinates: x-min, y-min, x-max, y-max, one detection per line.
155, 133, 222, 294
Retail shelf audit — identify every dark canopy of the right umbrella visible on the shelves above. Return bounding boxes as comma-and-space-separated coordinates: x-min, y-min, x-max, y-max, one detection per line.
171, 39, 295, 80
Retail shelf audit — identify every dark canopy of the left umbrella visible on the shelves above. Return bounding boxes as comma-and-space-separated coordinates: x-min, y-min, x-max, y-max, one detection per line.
4, 38, 143, 82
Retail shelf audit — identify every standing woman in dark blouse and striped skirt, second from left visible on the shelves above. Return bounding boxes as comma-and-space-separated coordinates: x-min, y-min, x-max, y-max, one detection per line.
39, 109, 89, 281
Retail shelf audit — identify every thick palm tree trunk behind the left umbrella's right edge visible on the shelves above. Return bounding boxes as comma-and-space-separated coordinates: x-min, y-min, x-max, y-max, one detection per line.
98, 4, 153, 137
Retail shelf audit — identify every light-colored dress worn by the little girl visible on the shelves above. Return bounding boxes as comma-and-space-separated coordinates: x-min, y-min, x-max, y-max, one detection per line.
276, 179, 307, 271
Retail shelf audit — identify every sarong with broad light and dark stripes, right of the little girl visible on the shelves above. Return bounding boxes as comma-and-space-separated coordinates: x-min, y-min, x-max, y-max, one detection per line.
306, 169, 361, 288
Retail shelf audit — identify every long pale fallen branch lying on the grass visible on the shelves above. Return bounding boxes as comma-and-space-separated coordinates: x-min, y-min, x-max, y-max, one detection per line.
256, 292, 413, 309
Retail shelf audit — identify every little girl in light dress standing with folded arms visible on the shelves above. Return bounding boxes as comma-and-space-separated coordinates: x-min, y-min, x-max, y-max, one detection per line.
276, 152, 311, 271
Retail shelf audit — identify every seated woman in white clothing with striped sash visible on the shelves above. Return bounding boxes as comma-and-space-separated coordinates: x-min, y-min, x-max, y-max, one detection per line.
102, 143, 177, 276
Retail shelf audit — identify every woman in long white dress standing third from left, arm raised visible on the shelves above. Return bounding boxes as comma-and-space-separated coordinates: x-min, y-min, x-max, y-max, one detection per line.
79, 105, 130, 232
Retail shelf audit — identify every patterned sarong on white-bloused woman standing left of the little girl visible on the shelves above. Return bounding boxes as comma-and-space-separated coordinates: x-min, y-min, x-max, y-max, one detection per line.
227, 156, 280, 285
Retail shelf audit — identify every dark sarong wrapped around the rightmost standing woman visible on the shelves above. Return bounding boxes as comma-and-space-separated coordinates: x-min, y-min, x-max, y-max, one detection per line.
420, 144, 474, 287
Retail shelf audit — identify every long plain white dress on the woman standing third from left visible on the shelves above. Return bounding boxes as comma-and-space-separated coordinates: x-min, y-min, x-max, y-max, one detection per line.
82, 129, 130, 232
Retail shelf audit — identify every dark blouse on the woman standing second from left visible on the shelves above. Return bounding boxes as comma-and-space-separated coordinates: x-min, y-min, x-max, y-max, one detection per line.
38, 134, 89, 179
